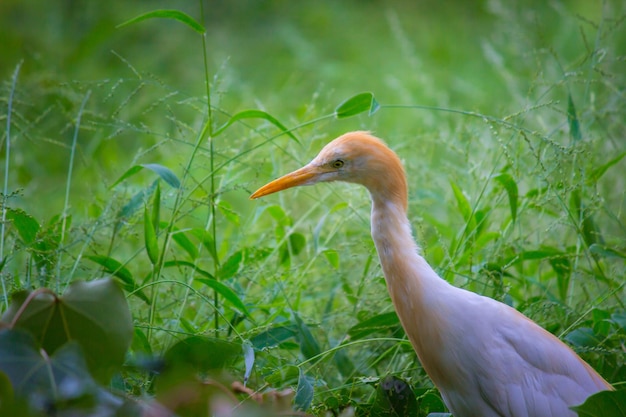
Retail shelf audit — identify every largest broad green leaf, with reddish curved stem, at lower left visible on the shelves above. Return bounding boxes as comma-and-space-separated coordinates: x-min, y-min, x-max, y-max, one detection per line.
2, 279, 133, 383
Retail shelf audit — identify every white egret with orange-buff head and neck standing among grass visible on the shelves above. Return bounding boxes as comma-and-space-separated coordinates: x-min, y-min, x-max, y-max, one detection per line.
250, 131, 613, 417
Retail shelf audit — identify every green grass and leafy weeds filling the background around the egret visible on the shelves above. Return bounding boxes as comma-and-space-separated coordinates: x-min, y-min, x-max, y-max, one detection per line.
0, 0, 626, 415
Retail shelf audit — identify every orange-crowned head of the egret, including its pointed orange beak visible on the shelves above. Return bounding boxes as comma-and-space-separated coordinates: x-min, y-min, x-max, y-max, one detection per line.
250, 132, 407, 208
